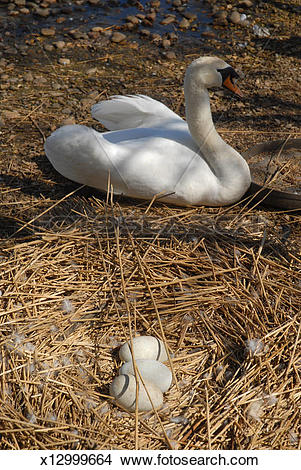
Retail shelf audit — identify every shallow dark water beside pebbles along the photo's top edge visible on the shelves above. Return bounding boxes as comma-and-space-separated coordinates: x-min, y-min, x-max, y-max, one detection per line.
0, 0, 211, 40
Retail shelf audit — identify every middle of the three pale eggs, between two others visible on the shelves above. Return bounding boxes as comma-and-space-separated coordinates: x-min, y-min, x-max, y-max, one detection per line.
119, 359, 172, 393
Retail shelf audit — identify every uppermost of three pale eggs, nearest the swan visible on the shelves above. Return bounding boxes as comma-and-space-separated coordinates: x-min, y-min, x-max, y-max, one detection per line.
119, 336, 168, 362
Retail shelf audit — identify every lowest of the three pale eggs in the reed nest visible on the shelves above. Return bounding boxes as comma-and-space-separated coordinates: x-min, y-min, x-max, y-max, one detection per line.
110, 375, 163, 411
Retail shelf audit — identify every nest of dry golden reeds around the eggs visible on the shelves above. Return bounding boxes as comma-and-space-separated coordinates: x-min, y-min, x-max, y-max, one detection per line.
0, 191, 301, 449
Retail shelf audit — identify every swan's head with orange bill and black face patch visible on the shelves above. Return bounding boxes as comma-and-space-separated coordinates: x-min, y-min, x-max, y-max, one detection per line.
185, 57, 243, 96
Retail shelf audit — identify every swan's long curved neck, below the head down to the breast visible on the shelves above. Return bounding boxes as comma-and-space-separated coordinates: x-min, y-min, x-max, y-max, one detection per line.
184, 79, 251, 203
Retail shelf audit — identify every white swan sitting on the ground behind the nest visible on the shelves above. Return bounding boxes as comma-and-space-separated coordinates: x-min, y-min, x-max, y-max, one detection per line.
45, 57, 251, 206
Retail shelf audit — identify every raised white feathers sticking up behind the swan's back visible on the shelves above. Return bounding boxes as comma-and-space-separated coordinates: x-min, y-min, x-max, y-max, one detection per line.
92, 95, 181, 131
